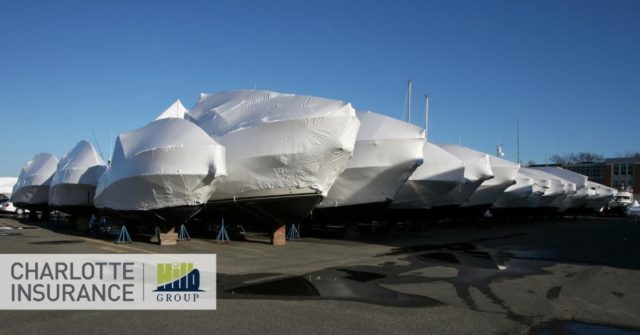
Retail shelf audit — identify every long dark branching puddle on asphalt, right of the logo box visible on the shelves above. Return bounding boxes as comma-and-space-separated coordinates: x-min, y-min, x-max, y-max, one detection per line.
219, 243, 548, 316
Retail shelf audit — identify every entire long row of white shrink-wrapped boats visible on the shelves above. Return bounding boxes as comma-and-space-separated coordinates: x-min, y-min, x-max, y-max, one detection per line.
11, 90, 616, 235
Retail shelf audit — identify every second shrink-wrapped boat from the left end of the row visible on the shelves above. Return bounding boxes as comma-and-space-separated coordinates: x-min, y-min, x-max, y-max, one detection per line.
49, 140, 107, 211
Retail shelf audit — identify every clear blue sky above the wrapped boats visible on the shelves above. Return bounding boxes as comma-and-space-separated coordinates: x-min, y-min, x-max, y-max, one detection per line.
0, 0, 640, 176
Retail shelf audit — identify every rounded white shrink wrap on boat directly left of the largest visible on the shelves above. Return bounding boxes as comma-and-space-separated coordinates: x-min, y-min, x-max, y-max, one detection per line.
94, 118, 226, 212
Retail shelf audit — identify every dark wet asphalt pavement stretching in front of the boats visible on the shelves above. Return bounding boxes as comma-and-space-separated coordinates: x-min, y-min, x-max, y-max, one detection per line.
0, 218, 640, 334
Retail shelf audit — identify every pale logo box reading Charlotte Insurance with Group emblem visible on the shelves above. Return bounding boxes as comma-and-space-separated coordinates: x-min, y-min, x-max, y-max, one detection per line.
0, 254, 216, 310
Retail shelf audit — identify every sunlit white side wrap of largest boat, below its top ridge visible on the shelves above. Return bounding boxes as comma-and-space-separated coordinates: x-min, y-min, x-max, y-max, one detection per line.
211, 116, 358, 201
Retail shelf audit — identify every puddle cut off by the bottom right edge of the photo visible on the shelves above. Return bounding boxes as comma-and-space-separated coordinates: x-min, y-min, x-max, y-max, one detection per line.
528, 320, 640, 335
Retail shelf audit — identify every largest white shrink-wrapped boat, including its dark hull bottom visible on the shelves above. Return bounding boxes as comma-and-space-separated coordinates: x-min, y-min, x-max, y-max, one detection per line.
185, 90, 360, 224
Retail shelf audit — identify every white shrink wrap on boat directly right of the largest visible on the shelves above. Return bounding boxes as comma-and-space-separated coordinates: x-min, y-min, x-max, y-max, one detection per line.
318, 112, 425, 208
